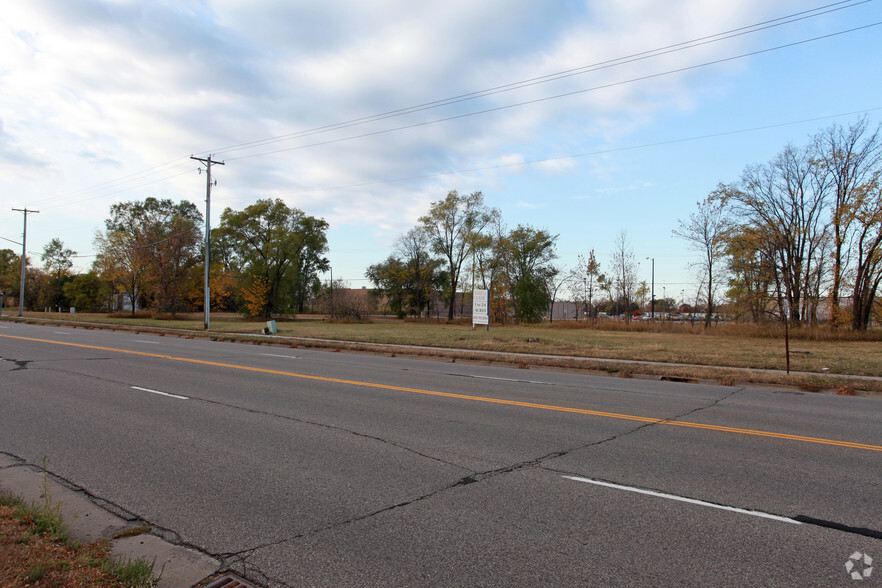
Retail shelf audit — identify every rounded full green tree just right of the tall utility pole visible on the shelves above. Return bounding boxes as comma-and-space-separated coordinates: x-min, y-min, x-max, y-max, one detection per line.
213, 198, 330, 316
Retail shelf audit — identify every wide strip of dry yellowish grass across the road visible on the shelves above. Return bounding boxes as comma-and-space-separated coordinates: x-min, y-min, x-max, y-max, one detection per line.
12, 313, 882, 387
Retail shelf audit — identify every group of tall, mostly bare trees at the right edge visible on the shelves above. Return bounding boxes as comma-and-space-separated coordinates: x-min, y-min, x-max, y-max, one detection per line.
674, 118, 882, 330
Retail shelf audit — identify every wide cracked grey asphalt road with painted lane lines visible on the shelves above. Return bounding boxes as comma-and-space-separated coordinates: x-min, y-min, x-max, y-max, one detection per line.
0, 322, 882, 586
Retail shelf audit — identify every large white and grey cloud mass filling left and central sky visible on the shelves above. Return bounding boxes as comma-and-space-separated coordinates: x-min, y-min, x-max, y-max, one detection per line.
0, 0, 872, 284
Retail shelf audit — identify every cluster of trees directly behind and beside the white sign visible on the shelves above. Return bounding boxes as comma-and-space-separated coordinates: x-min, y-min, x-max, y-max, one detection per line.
365, 190, 559, 323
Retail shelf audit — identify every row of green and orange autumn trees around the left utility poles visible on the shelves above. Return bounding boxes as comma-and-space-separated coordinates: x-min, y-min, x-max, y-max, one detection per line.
0, 197, 329, 317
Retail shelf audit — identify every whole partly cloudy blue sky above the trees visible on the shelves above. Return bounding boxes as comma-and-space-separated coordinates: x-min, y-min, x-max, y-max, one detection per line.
0, 0, 882, 300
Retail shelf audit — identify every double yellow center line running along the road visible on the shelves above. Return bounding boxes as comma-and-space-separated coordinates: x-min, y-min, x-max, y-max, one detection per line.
6, 335, 882, 451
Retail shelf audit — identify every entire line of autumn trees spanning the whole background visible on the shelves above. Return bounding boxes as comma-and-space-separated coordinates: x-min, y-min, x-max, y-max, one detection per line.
0, 118, 882, 330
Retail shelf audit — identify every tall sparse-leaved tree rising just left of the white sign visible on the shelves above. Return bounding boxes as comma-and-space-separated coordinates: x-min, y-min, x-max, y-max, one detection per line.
419, 190, 499, 320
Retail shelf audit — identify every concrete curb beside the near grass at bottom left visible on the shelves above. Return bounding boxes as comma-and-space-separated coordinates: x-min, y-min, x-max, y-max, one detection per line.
0, 453, 220, 588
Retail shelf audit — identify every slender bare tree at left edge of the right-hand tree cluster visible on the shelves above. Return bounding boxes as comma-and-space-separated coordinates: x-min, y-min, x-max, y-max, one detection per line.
674, 193, 731, 328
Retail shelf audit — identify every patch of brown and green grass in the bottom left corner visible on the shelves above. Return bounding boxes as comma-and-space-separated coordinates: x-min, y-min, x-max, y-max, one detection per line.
0, 462, 159, 588
